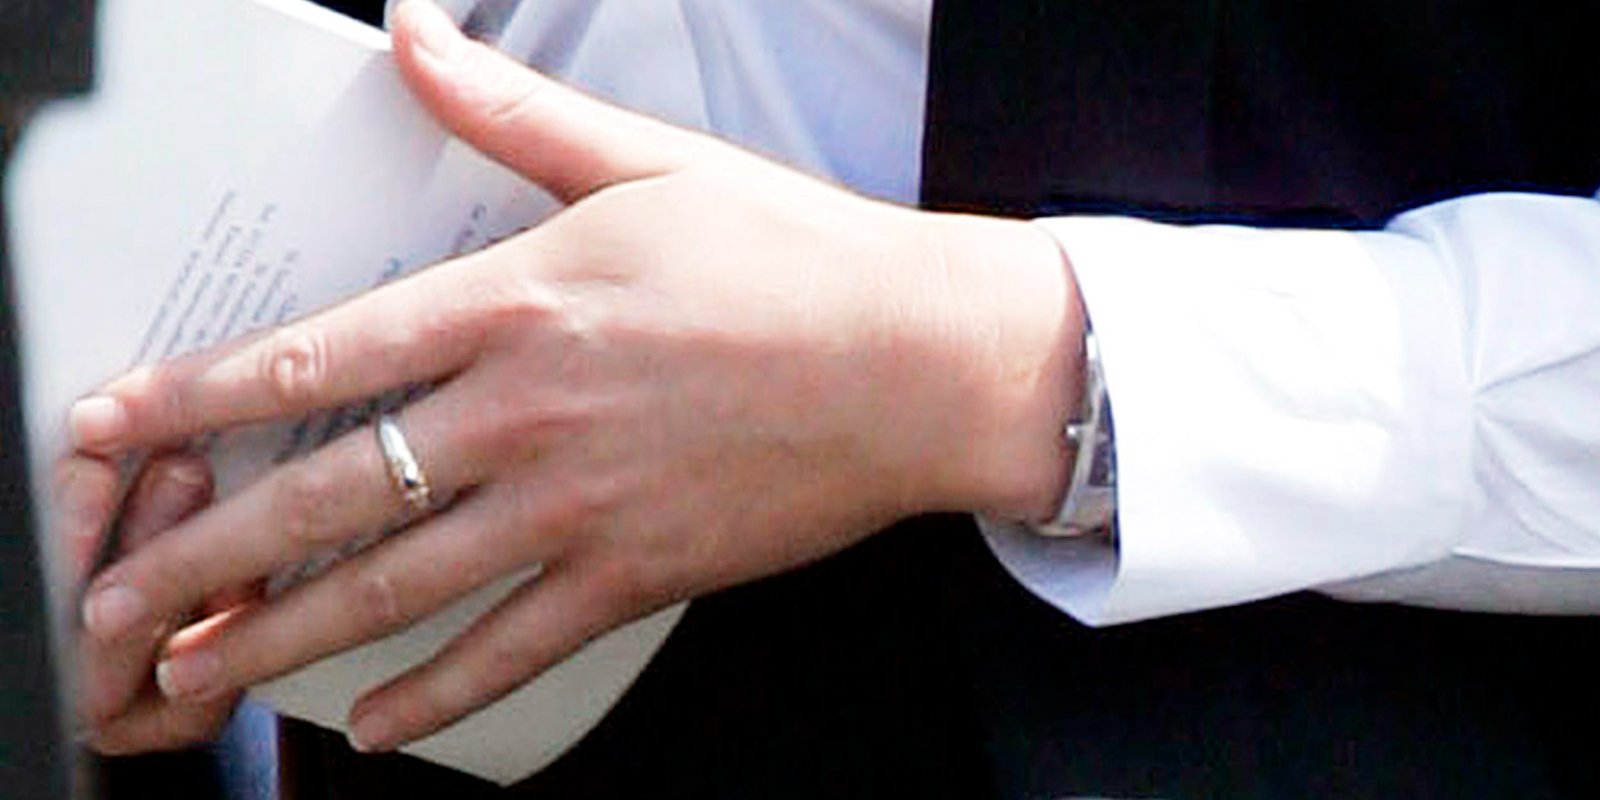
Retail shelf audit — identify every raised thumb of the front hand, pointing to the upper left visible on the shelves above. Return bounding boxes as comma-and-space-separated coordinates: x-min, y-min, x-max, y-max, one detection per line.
392, 0, 709, 203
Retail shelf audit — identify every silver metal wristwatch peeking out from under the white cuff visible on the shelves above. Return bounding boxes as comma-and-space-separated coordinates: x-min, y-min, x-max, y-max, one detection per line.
1030, 323, 1117, 536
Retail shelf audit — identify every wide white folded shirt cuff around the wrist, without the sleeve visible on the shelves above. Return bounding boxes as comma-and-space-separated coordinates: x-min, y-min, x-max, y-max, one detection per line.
987, 218, 1472, 624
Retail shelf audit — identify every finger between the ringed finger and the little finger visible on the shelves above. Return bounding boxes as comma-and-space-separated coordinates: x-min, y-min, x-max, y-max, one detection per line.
157, 486, 554, 702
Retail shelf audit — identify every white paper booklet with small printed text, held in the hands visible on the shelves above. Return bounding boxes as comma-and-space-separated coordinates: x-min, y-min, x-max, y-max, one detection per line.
10, 0, 683, 782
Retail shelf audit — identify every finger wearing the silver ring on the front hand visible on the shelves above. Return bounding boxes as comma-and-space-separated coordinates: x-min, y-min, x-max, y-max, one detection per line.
83, 389, 486, 652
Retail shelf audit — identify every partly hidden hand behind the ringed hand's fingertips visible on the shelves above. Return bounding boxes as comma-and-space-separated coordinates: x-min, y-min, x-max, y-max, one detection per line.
62, 454, 246, 755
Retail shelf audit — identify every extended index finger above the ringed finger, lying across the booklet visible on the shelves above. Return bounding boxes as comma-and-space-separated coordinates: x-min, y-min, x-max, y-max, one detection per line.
69, 256, 482, 454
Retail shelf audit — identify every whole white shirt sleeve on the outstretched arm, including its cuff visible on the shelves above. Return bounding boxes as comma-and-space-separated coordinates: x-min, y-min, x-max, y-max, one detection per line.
986, 194, 1600, 624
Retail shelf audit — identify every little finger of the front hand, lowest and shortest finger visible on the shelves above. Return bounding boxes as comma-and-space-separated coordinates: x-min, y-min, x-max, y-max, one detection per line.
350, 563, 630, 752
